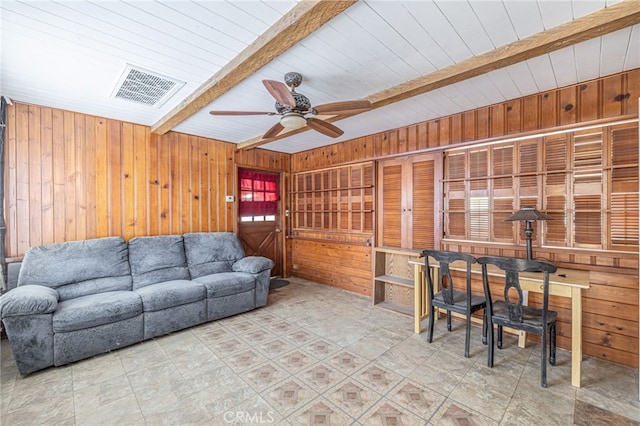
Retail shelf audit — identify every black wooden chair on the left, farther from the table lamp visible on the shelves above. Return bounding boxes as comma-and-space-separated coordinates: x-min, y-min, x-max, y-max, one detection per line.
422, 250, 487, 358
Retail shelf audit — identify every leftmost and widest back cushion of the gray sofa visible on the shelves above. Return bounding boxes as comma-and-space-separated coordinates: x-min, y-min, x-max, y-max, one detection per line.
18, 237, 132, 301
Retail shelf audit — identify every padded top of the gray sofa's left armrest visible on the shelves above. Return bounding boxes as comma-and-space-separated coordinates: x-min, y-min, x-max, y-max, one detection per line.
0, 285, 58, 318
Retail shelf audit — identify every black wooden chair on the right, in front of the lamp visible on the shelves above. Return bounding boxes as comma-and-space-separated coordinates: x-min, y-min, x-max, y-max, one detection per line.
478, 257, 558, 388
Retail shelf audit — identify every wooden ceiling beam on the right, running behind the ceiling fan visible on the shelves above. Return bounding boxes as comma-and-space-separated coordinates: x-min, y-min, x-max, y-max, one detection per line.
238, 0, 640, 149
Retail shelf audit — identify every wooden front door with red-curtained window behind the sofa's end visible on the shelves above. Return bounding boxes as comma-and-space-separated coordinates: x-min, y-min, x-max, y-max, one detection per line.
237, 169, 283, 277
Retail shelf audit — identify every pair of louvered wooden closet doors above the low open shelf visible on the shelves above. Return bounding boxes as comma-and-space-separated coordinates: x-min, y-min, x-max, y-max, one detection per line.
377, 154, 442, 250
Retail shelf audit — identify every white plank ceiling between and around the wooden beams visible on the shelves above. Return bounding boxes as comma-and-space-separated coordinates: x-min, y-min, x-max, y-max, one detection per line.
0, 0, 640, 153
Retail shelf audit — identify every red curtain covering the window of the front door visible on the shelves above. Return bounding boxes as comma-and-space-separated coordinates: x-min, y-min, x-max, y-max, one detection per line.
238, 169, 278, 216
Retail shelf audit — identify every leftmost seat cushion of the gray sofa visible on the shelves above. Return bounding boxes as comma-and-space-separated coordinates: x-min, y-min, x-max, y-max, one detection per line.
53, 291, 142, 333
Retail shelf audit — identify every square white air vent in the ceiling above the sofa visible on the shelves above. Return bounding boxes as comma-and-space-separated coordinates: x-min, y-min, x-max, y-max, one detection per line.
112, 65, 185, 107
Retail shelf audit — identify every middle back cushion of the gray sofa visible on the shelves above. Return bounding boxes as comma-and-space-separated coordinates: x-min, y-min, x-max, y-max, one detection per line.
129, 235, 191, 290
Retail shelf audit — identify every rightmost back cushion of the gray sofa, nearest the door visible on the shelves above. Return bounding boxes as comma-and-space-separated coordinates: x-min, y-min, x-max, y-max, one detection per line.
184, 232, 244, 279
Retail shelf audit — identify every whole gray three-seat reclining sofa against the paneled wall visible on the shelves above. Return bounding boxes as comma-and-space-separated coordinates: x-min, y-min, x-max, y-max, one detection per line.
0, 232, 274, 375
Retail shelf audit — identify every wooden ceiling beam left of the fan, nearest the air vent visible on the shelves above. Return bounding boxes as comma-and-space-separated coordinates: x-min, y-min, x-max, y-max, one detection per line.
151, 0, 357, 135
